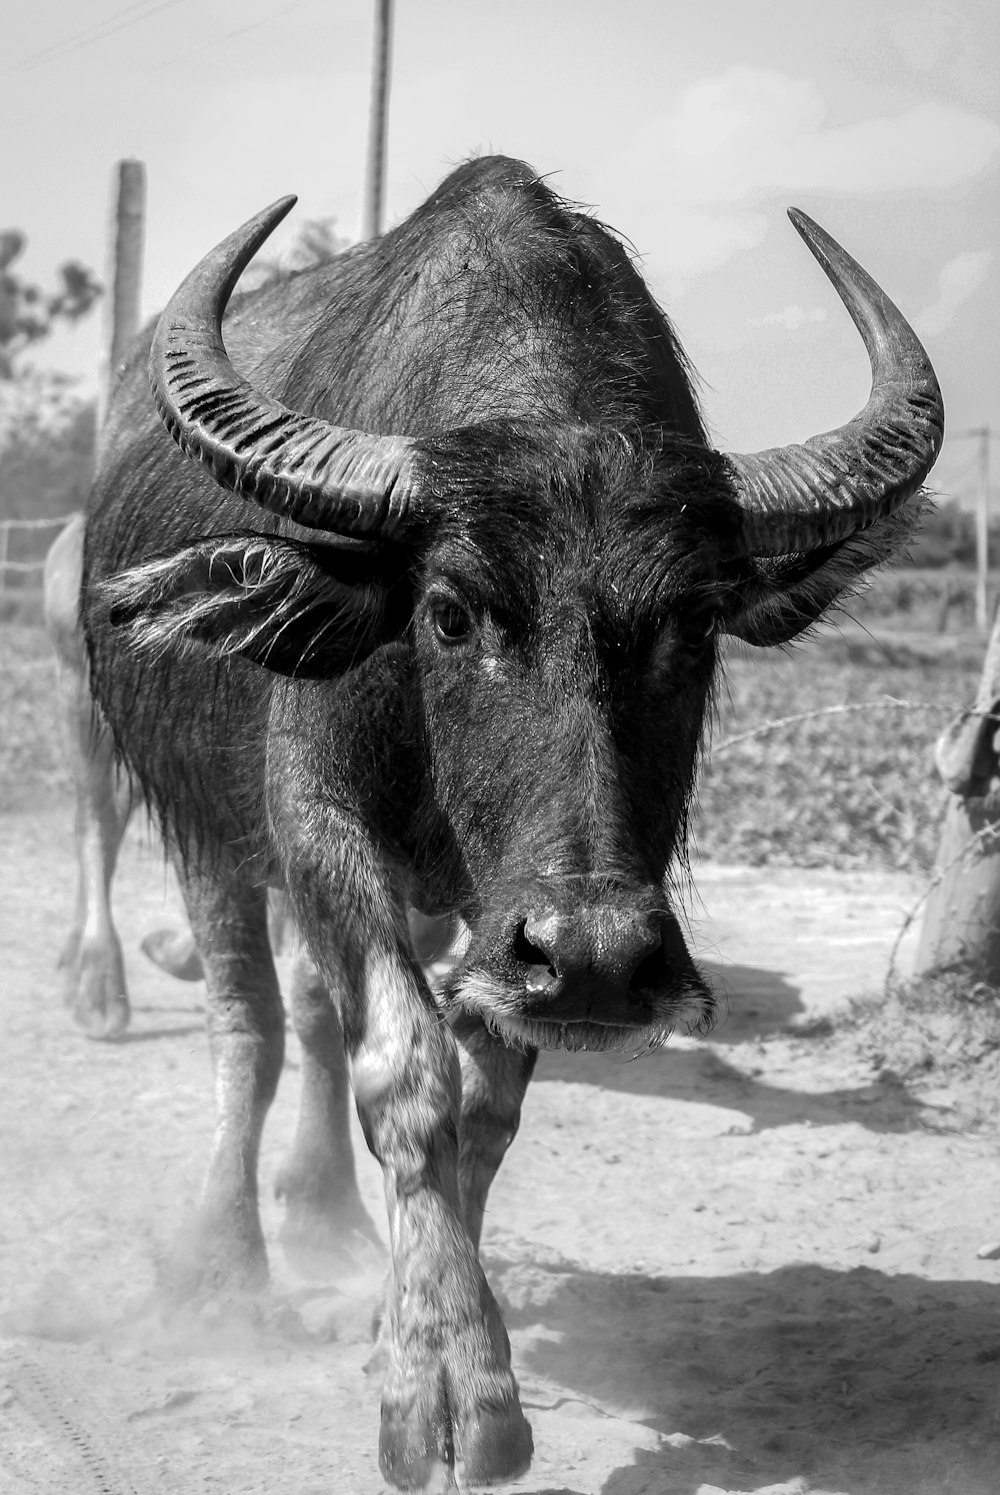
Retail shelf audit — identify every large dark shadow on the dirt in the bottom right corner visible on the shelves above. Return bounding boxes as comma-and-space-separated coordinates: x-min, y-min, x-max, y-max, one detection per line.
496, 1266, 1000, 1495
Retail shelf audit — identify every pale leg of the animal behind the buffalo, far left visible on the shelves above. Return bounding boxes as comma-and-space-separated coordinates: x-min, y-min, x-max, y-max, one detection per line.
45, 514, 132, 1039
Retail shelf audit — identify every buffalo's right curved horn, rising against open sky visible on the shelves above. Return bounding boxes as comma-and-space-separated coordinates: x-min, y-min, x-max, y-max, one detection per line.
728, 208, 945, 556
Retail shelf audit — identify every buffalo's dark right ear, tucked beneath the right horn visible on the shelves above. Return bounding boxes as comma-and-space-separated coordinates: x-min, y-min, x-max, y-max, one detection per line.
723, 495, 928, 649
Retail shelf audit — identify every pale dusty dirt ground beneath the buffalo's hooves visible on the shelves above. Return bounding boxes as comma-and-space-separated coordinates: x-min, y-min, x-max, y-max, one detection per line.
0, 806, 1000, 1495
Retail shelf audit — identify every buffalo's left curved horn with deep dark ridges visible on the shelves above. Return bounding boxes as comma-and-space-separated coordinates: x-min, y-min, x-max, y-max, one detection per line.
149, 197, 416, 535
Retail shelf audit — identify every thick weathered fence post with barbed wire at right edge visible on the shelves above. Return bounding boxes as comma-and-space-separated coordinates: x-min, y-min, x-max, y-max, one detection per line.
915, 616, 1000, 985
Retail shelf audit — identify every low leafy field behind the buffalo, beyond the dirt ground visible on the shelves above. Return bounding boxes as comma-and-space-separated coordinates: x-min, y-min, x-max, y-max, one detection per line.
0, 623, 984, 872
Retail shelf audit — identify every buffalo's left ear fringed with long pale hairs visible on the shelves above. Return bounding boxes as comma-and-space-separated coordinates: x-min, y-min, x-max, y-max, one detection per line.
97, 534, 410, 680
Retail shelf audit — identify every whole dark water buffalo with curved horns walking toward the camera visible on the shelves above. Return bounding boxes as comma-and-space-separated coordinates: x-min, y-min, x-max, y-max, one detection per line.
82, 157, 943, 1486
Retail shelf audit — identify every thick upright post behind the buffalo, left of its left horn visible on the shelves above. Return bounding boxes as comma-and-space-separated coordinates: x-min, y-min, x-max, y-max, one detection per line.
97, 160, 146, 432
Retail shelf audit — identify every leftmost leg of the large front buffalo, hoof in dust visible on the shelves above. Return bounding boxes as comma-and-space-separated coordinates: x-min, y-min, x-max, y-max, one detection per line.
164, 866, 284, 1299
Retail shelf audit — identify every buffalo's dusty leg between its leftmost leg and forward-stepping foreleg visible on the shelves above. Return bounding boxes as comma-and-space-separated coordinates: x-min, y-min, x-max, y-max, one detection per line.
272, 936, 381, 1275
